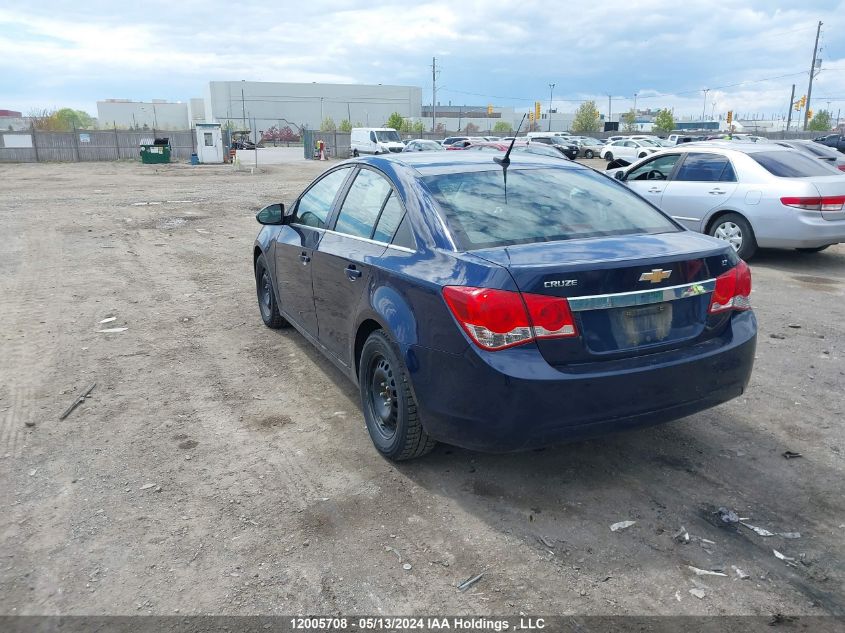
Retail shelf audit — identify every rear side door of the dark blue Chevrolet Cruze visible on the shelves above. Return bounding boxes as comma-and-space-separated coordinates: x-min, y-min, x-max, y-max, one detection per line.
313, 167, 404, 367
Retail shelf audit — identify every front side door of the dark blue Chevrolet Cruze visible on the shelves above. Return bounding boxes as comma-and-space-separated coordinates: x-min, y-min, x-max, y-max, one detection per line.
274, 167, 352, 337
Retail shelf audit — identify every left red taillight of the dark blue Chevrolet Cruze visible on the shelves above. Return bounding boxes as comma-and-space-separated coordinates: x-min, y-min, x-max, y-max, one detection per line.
443, 286, 576, 350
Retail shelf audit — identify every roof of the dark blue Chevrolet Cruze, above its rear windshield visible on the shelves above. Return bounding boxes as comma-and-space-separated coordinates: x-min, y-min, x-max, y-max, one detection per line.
348, 152, 590, 176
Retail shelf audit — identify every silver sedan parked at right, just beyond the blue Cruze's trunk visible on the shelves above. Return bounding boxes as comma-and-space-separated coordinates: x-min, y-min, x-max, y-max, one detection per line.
606, 142, 845, 259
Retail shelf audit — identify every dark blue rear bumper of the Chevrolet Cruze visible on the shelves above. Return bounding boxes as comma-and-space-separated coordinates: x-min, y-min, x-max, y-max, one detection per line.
406, 312, 757, 452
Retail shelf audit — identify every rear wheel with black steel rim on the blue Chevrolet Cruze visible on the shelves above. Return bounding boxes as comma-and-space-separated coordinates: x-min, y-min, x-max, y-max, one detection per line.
358, 330, 437, 461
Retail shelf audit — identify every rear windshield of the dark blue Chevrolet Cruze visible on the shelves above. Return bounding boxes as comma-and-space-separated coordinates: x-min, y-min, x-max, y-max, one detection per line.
423, 168, 681, 250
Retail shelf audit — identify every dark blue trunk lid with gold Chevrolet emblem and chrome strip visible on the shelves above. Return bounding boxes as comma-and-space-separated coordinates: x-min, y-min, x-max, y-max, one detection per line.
474, 232, 737, 365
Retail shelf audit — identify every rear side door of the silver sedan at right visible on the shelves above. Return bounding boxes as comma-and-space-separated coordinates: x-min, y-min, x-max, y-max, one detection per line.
660, 152, 738, 231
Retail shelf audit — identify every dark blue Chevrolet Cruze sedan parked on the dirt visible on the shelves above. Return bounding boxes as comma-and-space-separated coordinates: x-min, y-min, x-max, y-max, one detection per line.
254, 152, 757, 460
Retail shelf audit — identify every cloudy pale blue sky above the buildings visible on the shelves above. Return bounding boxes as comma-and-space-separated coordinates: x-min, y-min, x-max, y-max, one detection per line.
0, 0, 845, 116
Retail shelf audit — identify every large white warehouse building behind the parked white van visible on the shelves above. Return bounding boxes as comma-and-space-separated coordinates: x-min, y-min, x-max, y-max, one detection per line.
205, 81, 422, 132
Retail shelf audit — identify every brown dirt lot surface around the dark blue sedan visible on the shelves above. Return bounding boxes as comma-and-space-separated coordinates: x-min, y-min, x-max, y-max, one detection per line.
0, 162, 845, 614
